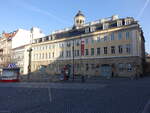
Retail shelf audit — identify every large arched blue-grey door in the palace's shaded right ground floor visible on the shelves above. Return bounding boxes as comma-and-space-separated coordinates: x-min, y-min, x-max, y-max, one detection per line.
101, 64, 112, 77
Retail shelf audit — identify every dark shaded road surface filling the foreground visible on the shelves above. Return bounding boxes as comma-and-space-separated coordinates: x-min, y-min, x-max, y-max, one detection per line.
0, 78, 150, 113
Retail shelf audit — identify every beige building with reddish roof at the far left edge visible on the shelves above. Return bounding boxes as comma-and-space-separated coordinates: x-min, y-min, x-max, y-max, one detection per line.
0, 31, 18, 67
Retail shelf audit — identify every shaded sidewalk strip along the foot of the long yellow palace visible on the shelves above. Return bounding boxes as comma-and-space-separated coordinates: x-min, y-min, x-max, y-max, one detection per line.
20, 74, 147, 83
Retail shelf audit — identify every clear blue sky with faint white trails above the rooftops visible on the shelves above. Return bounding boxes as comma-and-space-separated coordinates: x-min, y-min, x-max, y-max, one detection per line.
0, 0, 150, 53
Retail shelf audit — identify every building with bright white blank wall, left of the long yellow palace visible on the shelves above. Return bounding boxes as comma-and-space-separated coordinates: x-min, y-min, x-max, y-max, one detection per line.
12, 27, 45, 74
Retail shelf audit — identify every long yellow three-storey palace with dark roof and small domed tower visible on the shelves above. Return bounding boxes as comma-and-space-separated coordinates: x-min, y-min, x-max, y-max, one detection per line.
31, 11, 145, 76
